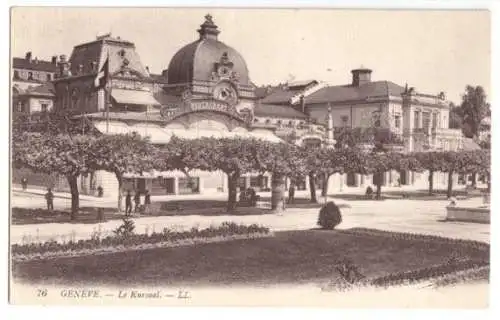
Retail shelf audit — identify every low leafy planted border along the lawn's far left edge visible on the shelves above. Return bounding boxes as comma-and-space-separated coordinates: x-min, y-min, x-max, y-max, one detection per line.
11, 222, 269, 257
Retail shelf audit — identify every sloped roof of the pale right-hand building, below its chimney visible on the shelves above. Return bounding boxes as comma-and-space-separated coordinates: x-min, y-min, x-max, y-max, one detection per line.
305, 81, 404, 104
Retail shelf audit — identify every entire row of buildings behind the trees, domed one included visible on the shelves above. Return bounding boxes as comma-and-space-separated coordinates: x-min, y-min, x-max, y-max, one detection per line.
13, 15, 470, 198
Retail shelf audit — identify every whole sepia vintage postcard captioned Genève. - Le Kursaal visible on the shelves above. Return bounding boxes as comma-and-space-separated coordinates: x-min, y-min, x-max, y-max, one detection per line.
9, 7, 492, 308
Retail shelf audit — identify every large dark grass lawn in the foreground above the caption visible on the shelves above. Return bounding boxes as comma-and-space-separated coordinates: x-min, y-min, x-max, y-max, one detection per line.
12, 230, 489, 287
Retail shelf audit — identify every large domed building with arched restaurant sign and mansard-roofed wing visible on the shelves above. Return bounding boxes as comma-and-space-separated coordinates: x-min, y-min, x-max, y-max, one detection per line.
44, 15, 312, 199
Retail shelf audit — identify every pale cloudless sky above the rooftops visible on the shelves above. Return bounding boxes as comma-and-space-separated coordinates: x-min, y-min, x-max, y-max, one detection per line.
11, 7, 491, 103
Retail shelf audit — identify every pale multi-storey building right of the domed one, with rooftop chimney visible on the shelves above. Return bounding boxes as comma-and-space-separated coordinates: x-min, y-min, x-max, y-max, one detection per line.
262, 68, 468, 189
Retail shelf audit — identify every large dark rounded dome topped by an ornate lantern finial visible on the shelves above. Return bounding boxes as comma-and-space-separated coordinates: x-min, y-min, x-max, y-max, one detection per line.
167, 15, 250, 85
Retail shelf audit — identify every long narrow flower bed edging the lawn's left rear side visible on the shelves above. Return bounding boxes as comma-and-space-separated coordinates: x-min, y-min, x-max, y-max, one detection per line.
11, 222, 270, 261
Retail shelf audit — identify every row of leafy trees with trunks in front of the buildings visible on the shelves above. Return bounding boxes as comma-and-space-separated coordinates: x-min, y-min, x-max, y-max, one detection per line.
12, 132, 490, 218
